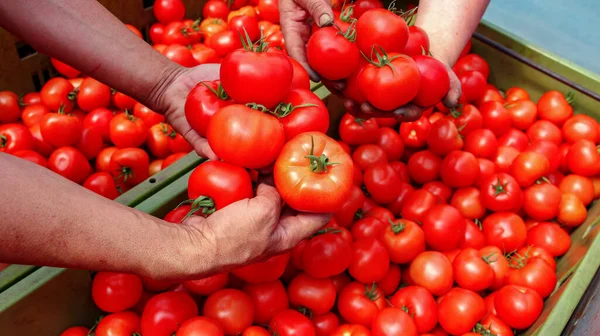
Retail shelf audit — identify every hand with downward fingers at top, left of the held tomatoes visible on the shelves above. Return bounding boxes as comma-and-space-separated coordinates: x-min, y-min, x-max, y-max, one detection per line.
279, 0, 334, 82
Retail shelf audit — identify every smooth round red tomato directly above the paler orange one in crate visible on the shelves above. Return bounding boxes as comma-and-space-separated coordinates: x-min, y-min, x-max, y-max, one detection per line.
422, 204, 466, 251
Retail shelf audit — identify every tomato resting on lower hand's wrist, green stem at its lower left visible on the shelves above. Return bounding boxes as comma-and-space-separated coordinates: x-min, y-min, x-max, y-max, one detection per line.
188, 161, 254, 215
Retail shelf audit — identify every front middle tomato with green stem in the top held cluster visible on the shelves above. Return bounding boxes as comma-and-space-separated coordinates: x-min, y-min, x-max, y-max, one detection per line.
358, 53, 421, 111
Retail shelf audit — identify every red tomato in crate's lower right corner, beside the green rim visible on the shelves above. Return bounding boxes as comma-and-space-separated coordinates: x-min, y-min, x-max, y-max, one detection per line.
494, 285, 544, 329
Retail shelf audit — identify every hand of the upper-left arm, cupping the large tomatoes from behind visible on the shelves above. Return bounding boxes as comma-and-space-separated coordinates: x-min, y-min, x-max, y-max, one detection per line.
154, 64, 220, 160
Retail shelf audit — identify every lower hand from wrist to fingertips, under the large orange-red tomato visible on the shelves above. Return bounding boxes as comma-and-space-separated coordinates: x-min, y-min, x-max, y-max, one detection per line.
183, 184, 331, 278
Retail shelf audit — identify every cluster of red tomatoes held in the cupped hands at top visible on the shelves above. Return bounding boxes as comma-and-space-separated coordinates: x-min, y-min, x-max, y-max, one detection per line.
307, 6, 450, 111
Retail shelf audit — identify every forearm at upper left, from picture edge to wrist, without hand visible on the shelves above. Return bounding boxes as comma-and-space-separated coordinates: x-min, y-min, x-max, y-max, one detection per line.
0, 0, 180, 109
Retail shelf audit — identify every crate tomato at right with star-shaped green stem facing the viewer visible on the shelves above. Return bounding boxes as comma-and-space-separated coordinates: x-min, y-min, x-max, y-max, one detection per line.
480, 173, 523, 212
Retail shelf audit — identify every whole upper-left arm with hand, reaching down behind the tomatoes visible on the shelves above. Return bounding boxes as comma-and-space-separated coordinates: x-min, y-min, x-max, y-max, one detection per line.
0, 0, 219, 159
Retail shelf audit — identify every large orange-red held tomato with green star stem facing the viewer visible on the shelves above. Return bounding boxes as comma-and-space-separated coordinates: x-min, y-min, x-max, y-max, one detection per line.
276, 132, 353, 212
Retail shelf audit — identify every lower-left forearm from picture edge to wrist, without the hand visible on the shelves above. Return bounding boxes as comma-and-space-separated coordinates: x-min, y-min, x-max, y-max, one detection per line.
0, 153, 208, 277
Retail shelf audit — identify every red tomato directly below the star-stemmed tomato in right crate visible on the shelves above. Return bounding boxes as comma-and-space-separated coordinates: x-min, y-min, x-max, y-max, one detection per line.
482, 212, 527, 252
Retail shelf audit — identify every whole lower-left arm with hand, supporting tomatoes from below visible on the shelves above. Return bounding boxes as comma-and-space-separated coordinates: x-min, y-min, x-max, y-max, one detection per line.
0, 153, 329, 279
